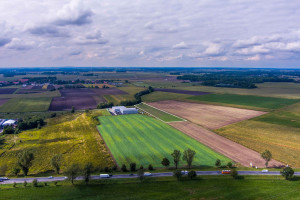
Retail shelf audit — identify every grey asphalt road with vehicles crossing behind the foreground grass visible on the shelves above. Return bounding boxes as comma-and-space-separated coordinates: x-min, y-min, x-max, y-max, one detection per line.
0, 171, 300, 184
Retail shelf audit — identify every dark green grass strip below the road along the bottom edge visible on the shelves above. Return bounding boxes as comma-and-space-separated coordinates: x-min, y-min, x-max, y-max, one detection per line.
0, 175, 300, 200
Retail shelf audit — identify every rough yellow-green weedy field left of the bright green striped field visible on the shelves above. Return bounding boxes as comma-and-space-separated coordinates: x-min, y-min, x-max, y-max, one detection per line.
0, 110, 114, 174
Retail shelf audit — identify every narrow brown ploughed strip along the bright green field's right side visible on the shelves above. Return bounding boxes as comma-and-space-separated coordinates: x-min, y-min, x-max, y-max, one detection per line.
169, 122, 283, 168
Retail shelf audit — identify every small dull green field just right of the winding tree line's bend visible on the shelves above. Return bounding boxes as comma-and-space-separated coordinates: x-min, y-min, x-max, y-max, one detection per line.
142, 91, 191, 102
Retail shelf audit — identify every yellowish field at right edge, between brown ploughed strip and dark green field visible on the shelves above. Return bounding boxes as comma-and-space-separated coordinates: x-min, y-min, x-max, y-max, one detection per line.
215, 120, 300, 167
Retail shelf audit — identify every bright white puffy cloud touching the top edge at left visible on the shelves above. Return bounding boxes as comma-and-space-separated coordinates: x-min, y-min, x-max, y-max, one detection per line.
53, 0, 94, 26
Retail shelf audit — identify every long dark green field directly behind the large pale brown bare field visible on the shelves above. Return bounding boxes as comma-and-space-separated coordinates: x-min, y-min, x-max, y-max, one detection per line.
188, 94, 300, 109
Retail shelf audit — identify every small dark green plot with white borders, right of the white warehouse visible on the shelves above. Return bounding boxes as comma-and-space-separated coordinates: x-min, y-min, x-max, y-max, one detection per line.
137, 103, 183, 122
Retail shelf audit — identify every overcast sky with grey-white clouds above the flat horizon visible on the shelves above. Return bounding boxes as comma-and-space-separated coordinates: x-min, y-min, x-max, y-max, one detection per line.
0, 0, 300, 68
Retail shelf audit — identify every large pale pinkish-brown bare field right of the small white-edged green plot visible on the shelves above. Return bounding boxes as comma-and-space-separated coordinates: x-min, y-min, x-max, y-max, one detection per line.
149, 101, 265, 129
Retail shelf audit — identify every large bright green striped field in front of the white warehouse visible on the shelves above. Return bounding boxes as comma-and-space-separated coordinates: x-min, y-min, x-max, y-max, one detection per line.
98, 114, 230, 167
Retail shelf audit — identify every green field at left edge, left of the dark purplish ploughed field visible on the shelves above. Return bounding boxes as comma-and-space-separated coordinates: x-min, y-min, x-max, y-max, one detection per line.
0, 97, 51, 112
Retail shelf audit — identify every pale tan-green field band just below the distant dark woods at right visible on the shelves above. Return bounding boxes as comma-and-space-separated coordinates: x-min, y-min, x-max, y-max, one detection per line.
169, 83, 300, 99
